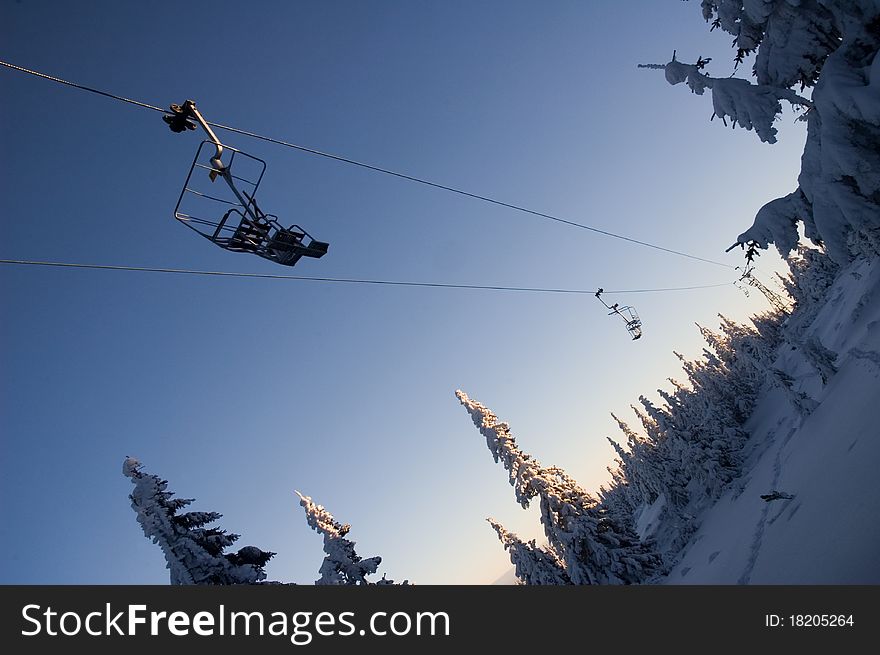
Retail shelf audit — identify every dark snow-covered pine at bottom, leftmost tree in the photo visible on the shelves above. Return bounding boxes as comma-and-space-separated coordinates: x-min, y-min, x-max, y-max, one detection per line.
122, 457, 275, 585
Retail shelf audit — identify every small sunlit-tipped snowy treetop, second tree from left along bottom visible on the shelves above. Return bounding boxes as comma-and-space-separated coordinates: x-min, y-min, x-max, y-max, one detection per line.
296, 491, 409, 585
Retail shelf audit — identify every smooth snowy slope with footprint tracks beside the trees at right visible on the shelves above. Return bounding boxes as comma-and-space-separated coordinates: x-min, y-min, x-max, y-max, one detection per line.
665, 260, 880, 584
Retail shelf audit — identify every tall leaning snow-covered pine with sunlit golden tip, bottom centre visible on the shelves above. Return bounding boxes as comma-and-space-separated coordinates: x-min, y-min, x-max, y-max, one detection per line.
455, 391, 662, 584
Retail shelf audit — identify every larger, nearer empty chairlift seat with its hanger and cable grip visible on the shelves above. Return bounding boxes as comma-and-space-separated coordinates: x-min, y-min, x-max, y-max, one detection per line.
163, 100, 329, 266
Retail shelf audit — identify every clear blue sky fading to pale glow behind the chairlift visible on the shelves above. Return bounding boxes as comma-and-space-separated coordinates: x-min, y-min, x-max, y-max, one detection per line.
0, 0, 804, 584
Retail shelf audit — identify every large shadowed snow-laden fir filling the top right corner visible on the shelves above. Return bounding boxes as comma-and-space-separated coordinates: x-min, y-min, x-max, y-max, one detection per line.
648, 0, 880, 264
